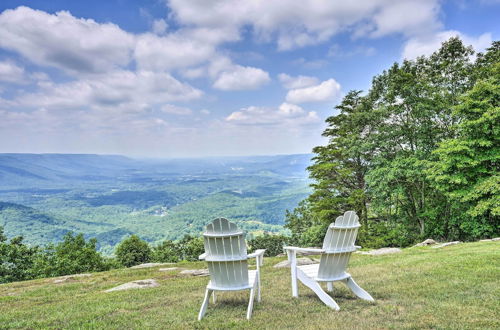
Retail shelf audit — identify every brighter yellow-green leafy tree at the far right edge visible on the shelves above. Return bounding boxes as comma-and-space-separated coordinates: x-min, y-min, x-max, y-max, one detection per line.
428, 62, 500, 237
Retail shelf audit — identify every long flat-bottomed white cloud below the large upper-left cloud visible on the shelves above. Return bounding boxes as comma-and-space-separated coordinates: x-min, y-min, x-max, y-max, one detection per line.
15, 70, 203, 112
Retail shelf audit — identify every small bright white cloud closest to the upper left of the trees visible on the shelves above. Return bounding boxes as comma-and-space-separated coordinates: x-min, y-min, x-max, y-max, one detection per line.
286, 79, 341, 104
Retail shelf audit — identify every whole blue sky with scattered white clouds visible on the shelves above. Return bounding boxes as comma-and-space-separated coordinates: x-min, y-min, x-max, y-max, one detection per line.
0, 0, 500, 157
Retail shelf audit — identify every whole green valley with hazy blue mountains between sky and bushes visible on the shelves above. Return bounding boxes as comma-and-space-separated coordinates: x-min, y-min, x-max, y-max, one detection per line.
0, 154, 312, 253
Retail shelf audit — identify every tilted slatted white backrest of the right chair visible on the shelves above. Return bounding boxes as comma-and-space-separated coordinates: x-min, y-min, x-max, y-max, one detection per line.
318, 211, 360, 279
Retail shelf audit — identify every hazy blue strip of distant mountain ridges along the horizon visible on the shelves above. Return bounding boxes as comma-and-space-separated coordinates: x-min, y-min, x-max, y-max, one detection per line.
0, 153, 311, 189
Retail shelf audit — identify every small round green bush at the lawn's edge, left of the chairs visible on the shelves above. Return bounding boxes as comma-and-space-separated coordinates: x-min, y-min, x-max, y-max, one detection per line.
115, 235, 151, 267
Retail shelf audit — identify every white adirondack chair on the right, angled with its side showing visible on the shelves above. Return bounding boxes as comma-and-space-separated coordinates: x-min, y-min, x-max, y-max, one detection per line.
284, 211, 374, 310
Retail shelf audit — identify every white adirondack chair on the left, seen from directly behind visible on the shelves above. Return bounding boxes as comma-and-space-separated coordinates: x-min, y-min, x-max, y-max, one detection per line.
198, 218, 265, 320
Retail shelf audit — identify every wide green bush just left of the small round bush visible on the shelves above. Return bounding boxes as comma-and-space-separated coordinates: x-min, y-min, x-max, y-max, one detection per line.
35, 233, 110, 277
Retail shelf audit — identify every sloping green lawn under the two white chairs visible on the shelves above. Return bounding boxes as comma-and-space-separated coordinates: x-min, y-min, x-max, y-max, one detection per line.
0, 242, 500, 329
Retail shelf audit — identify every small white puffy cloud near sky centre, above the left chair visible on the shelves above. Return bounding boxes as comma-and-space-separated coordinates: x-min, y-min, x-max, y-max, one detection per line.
213, 65, 271, 91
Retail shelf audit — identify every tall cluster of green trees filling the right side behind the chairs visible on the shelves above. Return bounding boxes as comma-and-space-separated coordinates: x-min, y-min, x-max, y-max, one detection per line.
286, 38, 500, 247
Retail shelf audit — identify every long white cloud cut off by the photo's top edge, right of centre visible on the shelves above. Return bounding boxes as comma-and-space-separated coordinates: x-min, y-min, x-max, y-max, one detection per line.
168, 0, 439, 50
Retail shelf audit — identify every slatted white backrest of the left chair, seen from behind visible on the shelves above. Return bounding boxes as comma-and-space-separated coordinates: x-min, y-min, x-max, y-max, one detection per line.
203, 218, 248, 288
